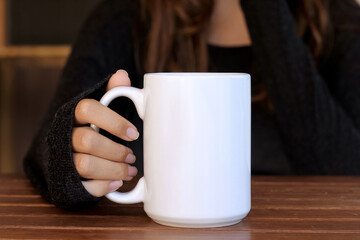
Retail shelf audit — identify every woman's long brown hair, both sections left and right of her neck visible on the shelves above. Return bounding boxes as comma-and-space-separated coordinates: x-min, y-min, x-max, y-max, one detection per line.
139, 0, 330, 72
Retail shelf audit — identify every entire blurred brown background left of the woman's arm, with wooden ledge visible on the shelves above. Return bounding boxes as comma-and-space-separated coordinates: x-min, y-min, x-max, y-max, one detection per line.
0, 0, 102, 173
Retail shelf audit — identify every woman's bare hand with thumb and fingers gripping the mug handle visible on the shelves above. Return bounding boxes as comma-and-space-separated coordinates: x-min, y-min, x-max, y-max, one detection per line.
72, 70, 139, 197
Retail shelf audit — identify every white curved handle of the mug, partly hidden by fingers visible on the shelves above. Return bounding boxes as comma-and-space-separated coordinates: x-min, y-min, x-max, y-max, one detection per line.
91, 87, 146, 204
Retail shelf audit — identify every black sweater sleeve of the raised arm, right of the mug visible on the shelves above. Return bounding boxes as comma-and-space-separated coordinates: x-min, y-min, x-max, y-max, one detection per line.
241, 0, 360, 175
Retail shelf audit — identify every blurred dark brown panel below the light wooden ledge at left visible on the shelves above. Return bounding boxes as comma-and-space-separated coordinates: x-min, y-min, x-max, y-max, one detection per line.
0, 57, 66, 172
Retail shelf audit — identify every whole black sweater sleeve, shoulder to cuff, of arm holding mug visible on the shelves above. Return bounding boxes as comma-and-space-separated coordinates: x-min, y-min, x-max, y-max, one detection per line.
23, 0, 138, 209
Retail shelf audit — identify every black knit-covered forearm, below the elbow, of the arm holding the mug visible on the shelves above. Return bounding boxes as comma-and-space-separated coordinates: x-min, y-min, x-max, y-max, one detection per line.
24, 79, 107, 209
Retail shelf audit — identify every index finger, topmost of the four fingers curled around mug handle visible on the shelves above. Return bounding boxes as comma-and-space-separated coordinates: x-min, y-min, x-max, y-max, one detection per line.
75, 99, 139, 141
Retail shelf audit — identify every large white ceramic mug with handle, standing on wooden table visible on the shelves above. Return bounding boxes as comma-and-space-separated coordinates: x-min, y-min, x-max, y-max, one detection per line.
92, 73, 251, 227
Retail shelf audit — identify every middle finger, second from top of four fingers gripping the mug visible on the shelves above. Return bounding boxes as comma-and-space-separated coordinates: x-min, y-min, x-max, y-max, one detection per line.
72, 127, 135, 163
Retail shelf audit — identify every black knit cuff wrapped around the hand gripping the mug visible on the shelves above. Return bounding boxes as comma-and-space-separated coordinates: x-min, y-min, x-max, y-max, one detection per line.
47, 76, 110, 209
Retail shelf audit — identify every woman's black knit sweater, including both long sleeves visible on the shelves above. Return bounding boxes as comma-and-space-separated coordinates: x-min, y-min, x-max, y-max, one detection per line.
24, 0, 360, 208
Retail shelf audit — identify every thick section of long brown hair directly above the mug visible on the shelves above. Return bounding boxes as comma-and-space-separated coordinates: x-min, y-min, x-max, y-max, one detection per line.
136, 0, 213, 72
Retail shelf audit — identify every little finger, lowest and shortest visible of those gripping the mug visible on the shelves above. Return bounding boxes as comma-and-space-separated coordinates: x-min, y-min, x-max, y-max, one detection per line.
82, 180, 123, 197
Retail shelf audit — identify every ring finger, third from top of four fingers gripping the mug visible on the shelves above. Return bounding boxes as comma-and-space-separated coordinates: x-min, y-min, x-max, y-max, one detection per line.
73, 153, 137, 180
